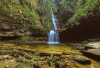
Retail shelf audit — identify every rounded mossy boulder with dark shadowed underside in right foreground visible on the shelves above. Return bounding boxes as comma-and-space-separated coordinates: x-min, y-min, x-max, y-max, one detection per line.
74, 55, 91, 64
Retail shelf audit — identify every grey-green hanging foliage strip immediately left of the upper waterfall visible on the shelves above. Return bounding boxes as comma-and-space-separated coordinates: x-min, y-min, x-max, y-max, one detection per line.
38, 0, 56, 28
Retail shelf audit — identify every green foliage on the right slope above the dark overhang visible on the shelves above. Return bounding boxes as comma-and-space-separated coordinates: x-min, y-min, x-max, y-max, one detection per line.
65, 0, 100, 27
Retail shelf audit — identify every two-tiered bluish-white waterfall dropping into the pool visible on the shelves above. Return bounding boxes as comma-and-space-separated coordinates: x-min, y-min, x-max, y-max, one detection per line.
48, 10, 59, 44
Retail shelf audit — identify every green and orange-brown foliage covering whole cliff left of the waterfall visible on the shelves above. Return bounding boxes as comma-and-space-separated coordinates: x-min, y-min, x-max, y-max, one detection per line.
0, 0, 54, 31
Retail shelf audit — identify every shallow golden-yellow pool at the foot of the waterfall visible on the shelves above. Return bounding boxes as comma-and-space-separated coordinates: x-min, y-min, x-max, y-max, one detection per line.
17, 44, 80, 54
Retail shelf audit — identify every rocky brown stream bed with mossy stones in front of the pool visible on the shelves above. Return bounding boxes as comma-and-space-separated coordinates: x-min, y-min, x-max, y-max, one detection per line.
0, 42, 100, 68
